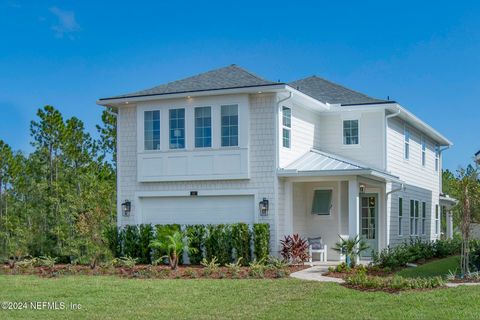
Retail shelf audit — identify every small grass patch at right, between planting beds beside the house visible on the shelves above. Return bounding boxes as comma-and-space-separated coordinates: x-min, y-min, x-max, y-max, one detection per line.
397, 256, 460, 278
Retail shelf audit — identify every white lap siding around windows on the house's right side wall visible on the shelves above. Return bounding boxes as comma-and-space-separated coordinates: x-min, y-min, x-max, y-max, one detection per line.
387, 118, 441, 244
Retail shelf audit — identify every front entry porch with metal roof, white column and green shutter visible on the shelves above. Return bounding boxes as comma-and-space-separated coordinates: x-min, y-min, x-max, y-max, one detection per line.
280, 151, 398, 262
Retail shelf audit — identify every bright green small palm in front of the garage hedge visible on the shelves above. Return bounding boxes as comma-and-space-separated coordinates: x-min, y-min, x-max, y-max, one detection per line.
150, 231, 197, 270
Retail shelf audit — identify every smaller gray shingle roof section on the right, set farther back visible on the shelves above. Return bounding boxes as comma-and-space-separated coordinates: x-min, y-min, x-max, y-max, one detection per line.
288, 76, 392, 105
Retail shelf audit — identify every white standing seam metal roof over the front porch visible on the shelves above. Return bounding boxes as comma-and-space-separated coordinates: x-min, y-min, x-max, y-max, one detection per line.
278, 149, 402, 182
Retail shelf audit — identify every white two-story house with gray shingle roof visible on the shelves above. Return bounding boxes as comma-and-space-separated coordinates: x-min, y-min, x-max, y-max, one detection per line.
98, 65, 451, 259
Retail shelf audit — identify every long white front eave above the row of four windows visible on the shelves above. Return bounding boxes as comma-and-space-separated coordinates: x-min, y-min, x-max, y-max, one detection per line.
97, 83, 286, 106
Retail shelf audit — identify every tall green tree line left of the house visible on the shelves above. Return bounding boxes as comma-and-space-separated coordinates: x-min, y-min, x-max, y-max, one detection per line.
0, 106, 116, 263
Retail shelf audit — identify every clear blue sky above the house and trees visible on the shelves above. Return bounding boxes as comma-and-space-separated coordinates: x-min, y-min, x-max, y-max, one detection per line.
0, 0, 480, 169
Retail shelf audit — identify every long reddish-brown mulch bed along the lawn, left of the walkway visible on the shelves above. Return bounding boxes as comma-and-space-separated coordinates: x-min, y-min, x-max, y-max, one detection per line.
0, 264, 308, 279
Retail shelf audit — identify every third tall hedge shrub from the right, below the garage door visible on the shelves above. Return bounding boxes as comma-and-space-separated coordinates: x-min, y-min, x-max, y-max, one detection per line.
205, 224, 232, 265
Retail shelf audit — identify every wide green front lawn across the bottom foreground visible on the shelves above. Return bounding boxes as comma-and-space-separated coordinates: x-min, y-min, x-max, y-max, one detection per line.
0, 276, 480, 320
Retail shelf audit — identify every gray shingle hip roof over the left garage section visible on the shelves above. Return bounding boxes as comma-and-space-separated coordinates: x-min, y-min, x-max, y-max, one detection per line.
100, 64, 280, 100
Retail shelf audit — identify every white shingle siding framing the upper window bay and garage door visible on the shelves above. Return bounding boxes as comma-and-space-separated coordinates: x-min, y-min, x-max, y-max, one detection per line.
118, 94, 277, 252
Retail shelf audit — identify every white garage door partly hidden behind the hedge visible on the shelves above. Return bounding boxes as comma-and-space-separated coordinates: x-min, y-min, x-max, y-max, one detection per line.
140, 195, 255, 224
